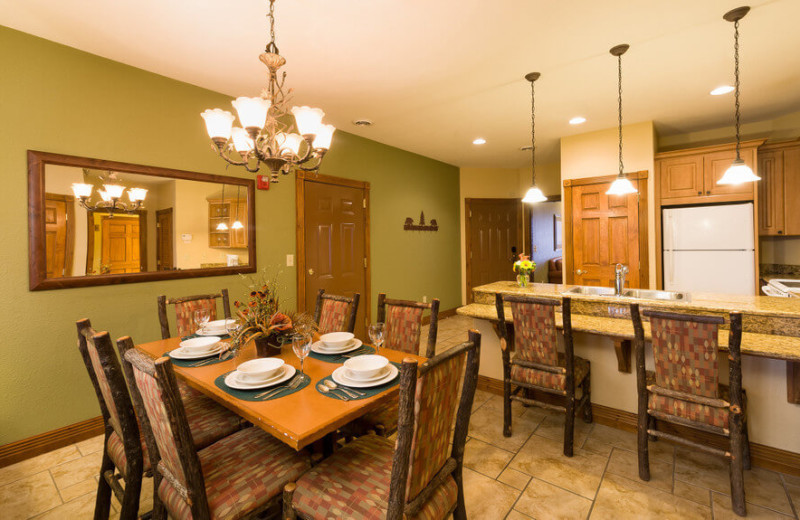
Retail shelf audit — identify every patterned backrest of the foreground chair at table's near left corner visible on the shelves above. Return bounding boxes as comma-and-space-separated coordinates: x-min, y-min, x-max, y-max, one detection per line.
125, 349, 208, 517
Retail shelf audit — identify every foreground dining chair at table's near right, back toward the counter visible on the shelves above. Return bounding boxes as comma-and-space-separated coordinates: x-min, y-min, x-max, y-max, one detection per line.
283, 330, 481, 520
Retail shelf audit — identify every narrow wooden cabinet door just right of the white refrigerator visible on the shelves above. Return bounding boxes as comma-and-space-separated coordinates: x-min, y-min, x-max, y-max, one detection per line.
758, 150, 784, 235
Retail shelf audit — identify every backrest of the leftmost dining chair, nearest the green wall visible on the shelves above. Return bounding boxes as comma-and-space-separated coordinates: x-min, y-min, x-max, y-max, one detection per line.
76, 319, 142, 477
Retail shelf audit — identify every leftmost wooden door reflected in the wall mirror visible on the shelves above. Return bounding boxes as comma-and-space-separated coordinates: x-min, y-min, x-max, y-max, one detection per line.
44, 193, 75, 278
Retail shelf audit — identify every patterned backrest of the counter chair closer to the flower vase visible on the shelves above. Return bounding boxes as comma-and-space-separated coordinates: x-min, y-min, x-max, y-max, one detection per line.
495, 293, 572, 366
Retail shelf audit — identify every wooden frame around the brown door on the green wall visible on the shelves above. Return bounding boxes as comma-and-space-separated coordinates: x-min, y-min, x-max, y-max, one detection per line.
295, 171, 372, 326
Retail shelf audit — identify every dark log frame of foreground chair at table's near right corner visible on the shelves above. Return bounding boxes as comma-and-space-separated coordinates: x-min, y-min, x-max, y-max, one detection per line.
283, 330, 481, 520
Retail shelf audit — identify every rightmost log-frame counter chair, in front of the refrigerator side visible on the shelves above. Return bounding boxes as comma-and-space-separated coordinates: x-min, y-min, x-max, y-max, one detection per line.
630, 304, 750, 516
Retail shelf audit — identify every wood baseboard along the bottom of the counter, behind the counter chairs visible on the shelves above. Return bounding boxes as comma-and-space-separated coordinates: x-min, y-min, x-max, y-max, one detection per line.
478, 376, 800, 476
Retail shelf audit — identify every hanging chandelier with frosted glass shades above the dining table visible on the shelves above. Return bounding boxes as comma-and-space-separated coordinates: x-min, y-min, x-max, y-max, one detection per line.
200, 0, 336, 182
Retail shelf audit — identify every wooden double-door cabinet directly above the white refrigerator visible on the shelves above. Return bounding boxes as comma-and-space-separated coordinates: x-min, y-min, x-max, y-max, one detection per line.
656, 140, 764, 206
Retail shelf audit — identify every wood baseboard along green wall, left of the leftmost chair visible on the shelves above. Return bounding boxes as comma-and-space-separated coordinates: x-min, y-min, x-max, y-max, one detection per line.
0, 416, 105, 468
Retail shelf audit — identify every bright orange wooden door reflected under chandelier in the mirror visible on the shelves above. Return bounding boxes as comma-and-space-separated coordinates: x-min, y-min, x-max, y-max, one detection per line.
100, 217, 141, 274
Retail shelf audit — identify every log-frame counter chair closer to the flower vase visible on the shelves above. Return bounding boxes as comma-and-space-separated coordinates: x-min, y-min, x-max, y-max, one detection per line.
495, 293, 592, 457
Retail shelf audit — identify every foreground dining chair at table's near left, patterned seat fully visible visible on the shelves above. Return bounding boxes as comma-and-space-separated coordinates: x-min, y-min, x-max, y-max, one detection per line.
125, 349, 310, 520
